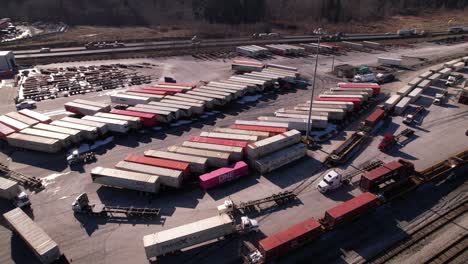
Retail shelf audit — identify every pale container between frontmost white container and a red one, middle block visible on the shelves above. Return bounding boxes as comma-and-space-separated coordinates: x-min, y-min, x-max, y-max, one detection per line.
115, 161, 184, 188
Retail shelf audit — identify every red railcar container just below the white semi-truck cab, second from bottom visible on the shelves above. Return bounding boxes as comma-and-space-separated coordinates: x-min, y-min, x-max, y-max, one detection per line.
322, 192, 379, 228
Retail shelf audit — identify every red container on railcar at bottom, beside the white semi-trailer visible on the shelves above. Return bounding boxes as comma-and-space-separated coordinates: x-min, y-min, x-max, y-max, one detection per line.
259, 218, 323, 260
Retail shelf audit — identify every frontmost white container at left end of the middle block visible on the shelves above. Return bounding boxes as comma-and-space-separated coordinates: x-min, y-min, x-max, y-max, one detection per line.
91, 167, 160, 193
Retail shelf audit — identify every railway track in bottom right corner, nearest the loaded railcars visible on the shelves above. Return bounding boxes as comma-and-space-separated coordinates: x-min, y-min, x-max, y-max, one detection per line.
368, 200, 468, 264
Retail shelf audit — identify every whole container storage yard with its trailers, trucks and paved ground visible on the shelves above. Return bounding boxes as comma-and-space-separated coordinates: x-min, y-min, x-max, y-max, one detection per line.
0, 28, 468, 263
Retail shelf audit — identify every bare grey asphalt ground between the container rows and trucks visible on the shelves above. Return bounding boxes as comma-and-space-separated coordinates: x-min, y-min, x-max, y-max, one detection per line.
0, 40, 468, 263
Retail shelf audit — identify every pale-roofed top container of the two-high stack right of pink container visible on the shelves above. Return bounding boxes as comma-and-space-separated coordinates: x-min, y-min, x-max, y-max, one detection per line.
247, 130, 301, 160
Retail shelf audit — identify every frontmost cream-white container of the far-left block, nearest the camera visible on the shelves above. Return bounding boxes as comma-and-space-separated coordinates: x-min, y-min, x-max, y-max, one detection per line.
7, 133, 63, 153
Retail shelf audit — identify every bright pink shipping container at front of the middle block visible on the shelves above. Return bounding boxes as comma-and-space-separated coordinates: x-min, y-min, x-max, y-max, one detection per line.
199, 161, 249, 190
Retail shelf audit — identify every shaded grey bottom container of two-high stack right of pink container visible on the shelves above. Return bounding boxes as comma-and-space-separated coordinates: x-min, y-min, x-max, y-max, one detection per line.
253, 143, 306, 174
